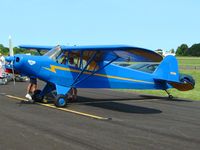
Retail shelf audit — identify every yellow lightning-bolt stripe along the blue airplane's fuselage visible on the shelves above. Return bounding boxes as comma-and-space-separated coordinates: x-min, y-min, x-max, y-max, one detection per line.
43, 65, 154, 84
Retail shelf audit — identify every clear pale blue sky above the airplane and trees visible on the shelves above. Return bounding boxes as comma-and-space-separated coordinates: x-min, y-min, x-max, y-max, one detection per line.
0, 0, 200, 50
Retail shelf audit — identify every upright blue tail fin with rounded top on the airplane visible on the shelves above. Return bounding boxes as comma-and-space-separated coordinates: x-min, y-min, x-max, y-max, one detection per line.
153, 55, 179, 82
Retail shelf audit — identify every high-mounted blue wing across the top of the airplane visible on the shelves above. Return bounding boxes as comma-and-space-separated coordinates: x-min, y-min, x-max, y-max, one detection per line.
19, 45, 163, 62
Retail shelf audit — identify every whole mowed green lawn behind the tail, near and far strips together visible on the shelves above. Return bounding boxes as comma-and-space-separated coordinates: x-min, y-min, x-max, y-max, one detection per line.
122, 57, 200, 100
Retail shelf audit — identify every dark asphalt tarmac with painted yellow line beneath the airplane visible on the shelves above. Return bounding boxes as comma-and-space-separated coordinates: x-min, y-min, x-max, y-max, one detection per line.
0, 82, 200, 150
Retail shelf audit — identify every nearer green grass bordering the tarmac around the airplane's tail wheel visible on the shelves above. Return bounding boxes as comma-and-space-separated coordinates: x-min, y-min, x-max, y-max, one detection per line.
126, 70, 200, 100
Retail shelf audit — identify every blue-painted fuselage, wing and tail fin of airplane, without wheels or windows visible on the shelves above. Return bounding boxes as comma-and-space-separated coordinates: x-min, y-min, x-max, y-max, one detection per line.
7, 45, 194, 97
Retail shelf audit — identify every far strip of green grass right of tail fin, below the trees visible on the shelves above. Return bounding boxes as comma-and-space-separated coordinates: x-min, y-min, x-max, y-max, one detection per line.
176, 57, 200, 66
